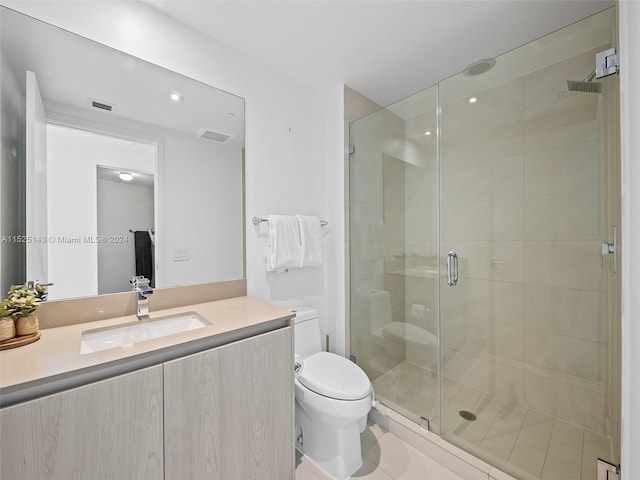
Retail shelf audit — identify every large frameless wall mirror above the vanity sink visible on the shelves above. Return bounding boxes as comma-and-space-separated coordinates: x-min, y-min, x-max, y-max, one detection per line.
0, 7, 244, 300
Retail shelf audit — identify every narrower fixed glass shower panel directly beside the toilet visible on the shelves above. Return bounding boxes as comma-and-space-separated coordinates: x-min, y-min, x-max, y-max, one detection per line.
349, 87, 439, 431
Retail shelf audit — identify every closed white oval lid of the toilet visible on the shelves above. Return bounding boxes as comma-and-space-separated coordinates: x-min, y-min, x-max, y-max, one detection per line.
297, 352, 371, 400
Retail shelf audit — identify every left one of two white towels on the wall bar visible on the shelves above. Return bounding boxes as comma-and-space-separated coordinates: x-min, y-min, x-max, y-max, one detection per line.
266, 215, 302, 272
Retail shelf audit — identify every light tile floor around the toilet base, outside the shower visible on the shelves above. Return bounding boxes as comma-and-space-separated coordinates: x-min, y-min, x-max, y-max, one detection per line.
296, 423, 463, 480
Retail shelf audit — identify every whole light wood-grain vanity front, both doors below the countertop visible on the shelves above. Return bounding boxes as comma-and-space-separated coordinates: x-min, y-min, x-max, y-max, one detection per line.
0, 326, 294, 480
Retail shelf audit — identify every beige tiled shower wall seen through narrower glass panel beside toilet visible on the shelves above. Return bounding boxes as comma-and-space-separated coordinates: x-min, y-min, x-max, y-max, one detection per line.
349, 103, 438, 380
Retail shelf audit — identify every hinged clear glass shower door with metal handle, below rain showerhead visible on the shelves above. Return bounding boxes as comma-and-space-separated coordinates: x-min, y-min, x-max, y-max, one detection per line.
440, 10, 617, 480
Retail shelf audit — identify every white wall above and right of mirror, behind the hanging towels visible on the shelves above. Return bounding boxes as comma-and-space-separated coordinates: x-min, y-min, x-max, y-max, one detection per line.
3, 1, 332, 336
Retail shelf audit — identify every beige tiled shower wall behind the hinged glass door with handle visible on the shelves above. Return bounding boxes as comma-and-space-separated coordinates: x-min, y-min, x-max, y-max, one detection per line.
441, 46, 607, 433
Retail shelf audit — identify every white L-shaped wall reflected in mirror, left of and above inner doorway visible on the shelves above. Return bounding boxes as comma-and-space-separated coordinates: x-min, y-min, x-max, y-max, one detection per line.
47, 125, 155, 300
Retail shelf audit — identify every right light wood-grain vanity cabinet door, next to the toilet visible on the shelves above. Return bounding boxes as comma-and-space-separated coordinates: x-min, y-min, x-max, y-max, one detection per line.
164, 327, 294, 480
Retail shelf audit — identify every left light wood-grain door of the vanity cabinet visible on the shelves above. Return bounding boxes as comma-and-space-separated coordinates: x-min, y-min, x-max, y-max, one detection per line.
0, 365, 163, 480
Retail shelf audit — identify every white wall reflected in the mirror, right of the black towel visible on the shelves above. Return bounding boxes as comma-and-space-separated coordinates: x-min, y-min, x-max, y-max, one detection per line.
161, 129, 242, 286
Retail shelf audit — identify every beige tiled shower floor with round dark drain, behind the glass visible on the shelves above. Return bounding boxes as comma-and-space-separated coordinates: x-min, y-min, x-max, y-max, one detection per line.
373, 362, 612, 480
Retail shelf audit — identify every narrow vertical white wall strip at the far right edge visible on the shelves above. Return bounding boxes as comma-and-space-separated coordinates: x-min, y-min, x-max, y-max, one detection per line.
618, 0, 640, 480
